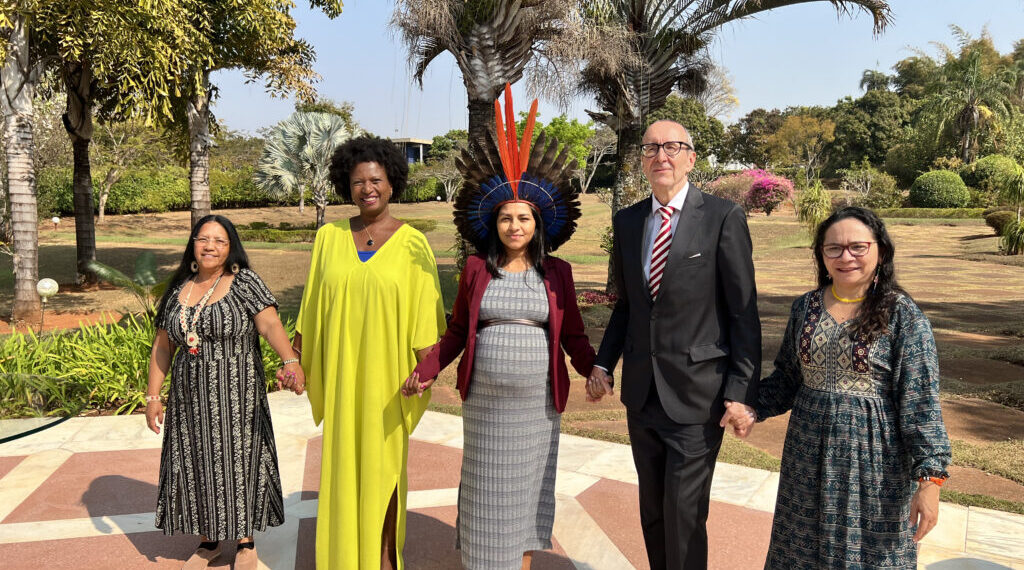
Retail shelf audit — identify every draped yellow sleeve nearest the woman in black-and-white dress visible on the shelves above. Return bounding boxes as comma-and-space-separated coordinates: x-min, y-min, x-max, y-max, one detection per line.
295, 225, 331, 425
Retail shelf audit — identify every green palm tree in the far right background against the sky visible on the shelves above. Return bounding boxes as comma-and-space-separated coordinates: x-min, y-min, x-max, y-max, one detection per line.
926, 42, 1017, 164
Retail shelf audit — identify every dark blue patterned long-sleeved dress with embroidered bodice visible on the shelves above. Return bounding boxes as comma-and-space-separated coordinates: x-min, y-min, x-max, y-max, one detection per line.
757, 290, 950, 570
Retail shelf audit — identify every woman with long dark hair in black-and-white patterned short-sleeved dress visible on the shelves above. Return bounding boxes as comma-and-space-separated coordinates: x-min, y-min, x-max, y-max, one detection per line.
145, 215, 303, 570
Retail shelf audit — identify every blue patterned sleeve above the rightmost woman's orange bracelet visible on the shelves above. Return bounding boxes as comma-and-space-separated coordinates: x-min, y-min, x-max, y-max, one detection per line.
890, 297, 952, 479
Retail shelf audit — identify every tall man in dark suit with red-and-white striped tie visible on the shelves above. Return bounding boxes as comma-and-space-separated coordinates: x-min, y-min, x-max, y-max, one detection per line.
588, 121, 761, 570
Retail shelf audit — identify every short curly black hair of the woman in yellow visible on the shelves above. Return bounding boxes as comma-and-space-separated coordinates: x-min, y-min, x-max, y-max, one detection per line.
330, 135, 409, 203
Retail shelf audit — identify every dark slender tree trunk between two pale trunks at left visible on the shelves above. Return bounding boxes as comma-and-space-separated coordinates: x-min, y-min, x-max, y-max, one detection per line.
62, 61, 98, 284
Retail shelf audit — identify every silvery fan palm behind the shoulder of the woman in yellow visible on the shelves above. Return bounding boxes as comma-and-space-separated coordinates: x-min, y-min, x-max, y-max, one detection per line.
253, 113, 359, 227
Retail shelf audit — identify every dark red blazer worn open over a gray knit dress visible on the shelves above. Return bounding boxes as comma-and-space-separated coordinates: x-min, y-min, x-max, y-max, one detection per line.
416, 255, 594, 412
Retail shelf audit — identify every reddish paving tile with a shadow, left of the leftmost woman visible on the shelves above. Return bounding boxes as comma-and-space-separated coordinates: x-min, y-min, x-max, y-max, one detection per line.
3, 449, 160, 523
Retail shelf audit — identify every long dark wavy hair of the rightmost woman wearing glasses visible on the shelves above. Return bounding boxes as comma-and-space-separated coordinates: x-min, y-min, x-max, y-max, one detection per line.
814, 206, 909, 342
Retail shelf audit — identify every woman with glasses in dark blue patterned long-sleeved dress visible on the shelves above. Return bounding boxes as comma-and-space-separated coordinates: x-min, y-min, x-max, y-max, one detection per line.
757, 208, 950, 570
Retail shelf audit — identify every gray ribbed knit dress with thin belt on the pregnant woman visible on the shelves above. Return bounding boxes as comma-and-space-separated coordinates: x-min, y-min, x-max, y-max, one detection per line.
457, 269, 561, 570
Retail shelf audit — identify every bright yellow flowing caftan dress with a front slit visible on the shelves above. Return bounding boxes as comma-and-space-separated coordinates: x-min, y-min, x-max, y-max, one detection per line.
296, 220, 444, 570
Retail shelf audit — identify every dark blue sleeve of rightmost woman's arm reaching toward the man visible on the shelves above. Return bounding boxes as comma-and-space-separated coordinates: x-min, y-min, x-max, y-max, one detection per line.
755, 295, 807, 422
